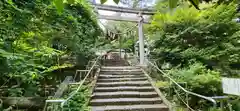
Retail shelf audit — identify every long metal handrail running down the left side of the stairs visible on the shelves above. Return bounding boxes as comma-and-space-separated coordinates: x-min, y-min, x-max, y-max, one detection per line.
44, 56, 102, 111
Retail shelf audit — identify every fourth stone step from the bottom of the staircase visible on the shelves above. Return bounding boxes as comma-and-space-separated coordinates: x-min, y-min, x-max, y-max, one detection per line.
95, 86, 155, 92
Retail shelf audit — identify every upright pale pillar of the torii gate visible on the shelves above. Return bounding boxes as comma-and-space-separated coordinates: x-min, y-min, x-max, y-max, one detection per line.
138, 12, 145, 65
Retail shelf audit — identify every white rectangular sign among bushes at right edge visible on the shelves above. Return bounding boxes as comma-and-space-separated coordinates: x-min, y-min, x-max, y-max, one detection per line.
222, 78, 240, 95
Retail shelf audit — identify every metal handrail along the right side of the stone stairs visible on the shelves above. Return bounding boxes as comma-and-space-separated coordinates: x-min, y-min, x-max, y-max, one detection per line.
146, 60, 217, 107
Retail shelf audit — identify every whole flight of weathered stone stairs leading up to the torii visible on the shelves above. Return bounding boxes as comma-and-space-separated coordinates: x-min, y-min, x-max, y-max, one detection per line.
90, 61, 169, 111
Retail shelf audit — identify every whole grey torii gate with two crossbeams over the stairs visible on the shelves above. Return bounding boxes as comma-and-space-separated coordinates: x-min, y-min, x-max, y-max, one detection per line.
94, 4, 155, 65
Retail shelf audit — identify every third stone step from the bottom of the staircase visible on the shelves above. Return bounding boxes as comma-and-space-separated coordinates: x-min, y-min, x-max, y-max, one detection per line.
93, 91, 158, 99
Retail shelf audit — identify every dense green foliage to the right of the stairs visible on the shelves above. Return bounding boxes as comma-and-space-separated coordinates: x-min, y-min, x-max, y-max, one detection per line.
148, 3, 240, 110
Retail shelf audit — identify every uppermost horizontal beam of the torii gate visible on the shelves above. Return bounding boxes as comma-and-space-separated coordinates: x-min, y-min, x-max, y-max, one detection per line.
95, 4, 156, 15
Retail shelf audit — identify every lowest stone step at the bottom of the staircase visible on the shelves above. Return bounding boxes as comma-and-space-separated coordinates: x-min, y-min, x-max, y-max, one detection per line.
91, 104, 169, 111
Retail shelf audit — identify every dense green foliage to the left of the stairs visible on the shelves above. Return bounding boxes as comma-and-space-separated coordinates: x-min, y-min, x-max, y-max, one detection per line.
0, 0, 100, 99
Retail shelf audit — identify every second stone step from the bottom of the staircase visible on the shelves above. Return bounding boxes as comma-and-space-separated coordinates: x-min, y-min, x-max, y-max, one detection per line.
90, 97, 162, 106
